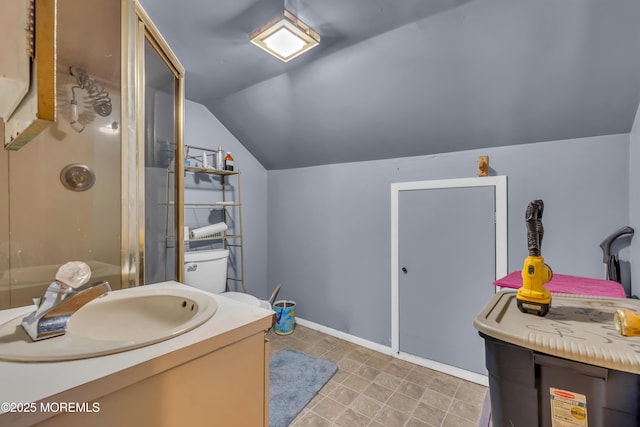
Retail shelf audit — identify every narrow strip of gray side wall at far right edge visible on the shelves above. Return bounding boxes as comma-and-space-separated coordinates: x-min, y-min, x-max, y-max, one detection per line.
629, 107, 640, 295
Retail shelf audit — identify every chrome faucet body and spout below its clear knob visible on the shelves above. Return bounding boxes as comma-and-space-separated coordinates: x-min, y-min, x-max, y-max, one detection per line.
22, 280, 111, 341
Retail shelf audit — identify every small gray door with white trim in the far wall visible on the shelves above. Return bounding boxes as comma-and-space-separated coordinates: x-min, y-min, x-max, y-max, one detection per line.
394, 177, 506, 382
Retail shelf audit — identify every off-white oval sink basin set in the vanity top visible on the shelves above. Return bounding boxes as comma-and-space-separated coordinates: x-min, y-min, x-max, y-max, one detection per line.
0, 286, 218, 362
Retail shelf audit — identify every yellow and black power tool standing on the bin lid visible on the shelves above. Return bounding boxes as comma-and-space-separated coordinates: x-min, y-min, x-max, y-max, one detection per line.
516, 200, 553, 316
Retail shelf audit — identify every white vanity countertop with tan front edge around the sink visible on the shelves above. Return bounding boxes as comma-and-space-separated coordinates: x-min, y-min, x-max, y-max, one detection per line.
0, 282, 274, 425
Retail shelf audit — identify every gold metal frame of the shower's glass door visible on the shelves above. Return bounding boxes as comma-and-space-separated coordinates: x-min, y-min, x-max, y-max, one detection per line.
121, 0, 185, 287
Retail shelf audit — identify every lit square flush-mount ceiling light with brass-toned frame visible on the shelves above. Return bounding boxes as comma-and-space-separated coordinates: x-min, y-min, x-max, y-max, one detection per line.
249, 10, 320, 62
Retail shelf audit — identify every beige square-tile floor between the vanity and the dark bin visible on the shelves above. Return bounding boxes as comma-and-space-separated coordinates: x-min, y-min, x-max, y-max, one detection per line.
268, 325, 487, 427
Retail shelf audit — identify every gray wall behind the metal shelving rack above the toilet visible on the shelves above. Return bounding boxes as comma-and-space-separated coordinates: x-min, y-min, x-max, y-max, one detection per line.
184, 101, 273, 298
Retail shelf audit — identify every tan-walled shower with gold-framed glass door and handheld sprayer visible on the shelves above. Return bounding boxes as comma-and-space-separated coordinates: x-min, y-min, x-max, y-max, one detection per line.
0, 0, 184, 309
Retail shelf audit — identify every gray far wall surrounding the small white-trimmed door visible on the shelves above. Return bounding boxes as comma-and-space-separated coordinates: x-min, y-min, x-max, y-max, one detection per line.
267, 134, 629, 345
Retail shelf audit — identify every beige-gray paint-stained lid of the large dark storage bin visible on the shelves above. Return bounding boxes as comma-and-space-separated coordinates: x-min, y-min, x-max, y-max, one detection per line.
473, 291, 640, 374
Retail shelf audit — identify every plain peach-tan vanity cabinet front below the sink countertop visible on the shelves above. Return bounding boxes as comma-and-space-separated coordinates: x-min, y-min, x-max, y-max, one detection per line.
37, 331, 269, 427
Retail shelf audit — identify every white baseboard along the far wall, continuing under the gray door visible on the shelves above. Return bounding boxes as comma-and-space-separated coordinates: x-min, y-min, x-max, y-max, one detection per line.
296, 317, 489, 387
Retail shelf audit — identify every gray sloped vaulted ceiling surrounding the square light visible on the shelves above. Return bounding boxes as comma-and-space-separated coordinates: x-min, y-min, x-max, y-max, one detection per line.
141, 0, 640, 169
